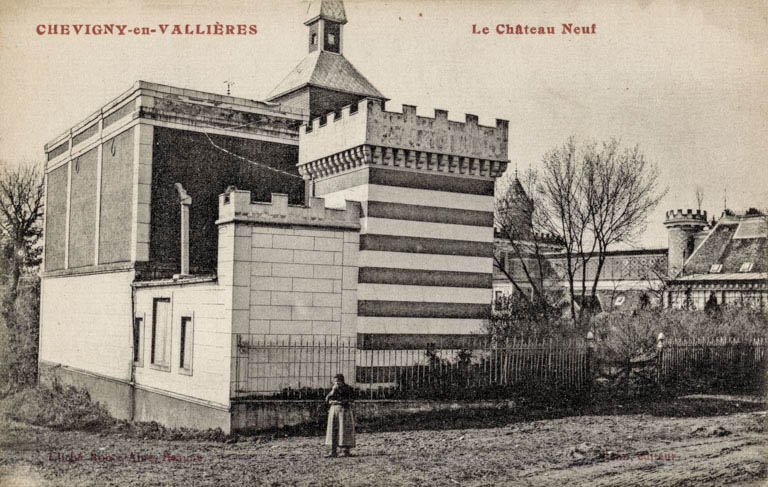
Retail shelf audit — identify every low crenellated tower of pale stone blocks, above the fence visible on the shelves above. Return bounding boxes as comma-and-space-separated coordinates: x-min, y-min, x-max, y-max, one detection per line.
217, 191, 360, 338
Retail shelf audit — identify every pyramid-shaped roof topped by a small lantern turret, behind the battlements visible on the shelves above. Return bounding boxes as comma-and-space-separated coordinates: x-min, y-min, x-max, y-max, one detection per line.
268, 0, 387, 119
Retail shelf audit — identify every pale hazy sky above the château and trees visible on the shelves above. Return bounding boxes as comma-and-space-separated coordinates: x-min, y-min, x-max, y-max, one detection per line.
0, 0, 768, 247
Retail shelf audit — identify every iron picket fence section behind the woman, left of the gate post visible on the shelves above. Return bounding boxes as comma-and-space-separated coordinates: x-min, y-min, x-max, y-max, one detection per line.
233, 335, 590, 399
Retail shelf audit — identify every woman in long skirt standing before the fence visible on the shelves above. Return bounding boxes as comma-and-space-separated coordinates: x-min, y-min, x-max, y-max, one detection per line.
325, 374, 355, 457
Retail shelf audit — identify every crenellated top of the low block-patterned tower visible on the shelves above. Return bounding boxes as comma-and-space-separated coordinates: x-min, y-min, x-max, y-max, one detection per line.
216, 190, 362, 230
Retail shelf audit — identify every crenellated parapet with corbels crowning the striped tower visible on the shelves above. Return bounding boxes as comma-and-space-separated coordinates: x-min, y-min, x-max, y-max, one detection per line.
299, 99, 508, 179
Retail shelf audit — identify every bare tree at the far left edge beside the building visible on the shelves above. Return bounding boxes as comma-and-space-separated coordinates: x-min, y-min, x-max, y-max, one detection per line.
0, 164, 44, 296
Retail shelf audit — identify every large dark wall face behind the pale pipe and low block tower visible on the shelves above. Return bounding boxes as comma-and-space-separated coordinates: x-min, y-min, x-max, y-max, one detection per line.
150, 127, 304, 272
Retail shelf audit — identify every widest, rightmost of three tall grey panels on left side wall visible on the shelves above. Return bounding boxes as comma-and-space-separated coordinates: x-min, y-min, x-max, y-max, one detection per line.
99, 128, 134, 264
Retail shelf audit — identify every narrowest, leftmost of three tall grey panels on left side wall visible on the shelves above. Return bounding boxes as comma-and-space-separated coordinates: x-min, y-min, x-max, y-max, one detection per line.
45, 164, 67, 271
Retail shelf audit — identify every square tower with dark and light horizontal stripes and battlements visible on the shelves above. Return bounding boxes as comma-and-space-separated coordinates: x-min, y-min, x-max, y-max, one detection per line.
299, 102, 507, 342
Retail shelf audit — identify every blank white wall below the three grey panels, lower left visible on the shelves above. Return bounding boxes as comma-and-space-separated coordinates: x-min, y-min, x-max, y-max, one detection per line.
39, 271, 133, 381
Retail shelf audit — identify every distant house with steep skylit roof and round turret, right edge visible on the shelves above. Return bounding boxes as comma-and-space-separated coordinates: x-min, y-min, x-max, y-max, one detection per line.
664, 209, 768, 310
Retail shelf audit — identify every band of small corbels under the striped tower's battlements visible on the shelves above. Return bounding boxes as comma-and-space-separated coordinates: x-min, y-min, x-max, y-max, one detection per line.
298, 145, 508, 183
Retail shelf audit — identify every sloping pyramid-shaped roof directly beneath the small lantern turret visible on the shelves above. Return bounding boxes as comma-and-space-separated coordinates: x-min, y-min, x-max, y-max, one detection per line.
267, 51, 387, 100
